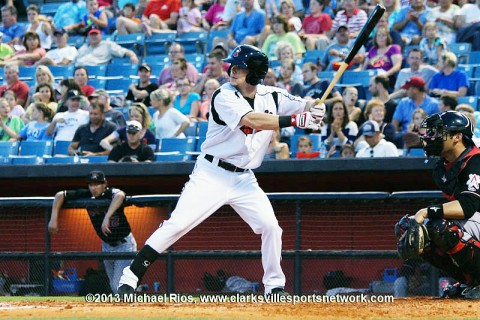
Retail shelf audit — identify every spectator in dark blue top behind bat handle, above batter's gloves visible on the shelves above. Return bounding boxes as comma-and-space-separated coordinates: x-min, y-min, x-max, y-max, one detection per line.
302, 62, 342, 105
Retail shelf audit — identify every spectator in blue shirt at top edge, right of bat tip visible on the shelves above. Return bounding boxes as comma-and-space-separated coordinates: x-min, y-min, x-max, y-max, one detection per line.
393, 0, 428, 45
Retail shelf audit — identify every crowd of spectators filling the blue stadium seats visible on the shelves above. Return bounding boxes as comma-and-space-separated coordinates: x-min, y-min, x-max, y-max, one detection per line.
0, 0, 480, 162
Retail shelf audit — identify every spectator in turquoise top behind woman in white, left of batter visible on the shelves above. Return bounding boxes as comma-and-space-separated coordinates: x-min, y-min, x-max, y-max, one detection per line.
173, 77, 202, 120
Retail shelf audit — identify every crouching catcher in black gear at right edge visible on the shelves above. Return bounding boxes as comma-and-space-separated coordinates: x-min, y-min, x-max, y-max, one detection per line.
395, 111, 480, 299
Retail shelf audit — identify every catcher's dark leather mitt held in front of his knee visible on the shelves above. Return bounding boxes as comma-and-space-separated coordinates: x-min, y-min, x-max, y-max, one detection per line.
395, 216, 429, 260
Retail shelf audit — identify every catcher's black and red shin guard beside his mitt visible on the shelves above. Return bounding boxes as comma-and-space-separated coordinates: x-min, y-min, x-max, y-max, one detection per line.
423, 219, 480, 285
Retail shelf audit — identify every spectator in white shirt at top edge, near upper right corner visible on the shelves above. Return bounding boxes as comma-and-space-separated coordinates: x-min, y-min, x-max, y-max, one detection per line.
427, 0, 460, 44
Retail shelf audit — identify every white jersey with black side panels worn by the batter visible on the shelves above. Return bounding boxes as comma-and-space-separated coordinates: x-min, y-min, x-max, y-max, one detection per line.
201, 83, 307, 169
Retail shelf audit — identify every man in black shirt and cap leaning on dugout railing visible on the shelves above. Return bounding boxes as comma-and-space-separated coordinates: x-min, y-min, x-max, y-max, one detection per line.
48, 171, 137, 293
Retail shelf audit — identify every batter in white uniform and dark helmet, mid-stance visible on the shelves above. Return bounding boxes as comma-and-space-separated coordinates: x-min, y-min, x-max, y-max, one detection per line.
118, 45, 325, 295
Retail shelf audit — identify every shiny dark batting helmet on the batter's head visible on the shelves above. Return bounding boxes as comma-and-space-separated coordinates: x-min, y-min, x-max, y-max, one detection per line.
223, 44, 268, 86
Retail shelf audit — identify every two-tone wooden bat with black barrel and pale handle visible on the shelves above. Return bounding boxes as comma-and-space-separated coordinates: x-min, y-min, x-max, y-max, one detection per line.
320, 4, 385, 103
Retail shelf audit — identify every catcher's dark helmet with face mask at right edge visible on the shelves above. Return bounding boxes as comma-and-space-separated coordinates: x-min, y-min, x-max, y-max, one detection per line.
419, 111, 475, 157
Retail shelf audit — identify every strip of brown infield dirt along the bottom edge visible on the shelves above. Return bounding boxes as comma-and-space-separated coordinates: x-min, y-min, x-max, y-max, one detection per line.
0, 297, 480, 320
